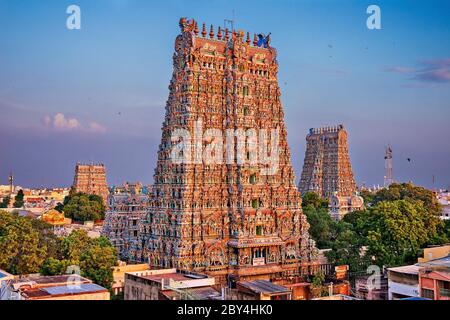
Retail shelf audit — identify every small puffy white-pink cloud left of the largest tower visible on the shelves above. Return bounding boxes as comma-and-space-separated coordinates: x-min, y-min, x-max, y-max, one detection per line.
42, 112, 106, 133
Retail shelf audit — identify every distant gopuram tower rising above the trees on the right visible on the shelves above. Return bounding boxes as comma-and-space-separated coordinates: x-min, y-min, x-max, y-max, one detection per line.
299, 125, 356, 198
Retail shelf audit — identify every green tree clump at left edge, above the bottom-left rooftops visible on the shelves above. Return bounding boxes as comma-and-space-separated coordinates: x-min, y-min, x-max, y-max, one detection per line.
0, 210, 117, 289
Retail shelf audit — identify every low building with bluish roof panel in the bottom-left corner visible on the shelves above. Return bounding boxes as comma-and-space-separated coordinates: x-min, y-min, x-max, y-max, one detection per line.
6, 275, 110, 300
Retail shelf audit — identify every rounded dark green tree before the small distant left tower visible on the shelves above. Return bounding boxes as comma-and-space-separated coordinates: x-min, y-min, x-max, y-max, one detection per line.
62, 193, 105, 222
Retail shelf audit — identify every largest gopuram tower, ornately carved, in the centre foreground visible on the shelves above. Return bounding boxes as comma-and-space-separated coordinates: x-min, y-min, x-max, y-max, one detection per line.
136, 18, 317, 284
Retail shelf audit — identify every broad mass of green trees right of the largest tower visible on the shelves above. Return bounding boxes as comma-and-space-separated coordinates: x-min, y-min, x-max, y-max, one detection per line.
303, 183, 450, 271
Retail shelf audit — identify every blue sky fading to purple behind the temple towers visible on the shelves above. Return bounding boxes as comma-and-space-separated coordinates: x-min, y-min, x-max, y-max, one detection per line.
0, 0, 450, 187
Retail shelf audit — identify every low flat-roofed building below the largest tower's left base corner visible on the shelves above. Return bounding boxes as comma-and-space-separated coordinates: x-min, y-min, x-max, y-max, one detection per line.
124, 269, 222, 300
